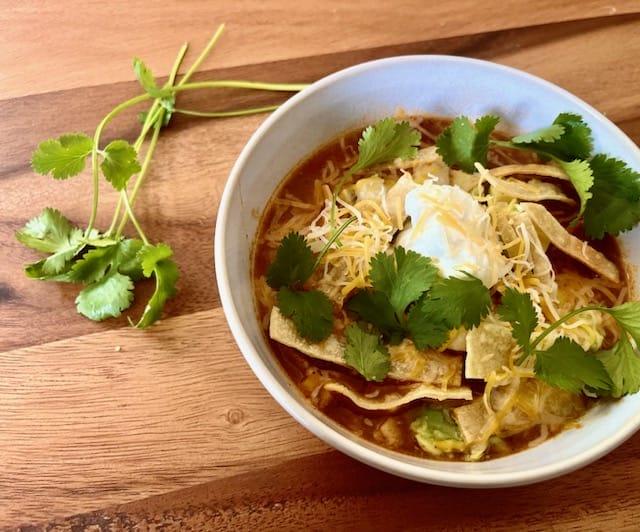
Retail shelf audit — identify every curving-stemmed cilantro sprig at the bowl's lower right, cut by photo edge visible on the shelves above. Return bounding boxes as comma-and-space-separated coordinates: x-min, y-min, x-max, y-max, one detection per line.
498, 288, 640, 397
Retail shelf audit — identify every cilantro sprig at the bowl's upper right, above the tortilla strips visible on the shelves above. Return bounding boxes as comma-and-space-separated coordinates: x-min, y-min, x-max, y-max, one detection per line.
436, 113, 640, 238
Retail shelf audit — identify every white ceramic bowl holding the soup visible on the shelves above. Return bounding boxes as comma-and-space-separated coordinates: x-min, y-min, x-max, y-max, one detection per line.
215, 55, 640, 487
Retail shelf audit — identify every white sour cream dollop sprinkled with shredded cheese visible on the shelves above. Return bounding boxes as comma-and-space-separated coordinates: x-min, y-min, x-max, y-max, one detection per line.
396, 181, 506, 288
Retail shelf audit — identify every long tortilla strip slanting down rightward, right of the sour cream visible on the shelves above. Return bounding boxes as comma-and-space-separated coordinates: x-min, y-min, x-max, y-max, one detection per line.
521, 203, 620, 283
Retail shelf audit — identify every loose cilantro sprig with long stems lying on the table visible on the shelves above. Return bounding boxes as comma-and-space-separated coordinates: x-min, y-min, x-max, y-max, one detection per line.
16, 25, 304, 328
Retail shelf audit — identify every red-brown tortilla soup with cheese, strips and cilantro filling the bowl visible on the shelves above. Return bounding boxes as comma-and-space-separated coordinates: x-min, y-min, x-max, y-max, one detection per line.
253, 116, 629, 460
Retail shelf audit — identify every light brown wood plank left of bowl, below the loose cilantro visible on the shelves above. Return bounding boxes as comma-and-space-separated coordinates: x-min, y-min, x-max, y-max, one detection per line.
0, 309, 327, 523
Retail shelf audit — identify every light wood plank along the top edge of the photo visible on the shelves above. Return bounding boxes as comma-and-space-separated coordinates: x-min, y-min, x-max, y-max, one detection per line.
0, 0, 640, 98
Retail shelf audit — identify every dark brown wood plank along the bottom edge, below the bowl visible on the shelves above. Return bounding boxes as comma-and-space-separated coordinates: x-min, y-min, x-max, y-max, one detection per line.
41, 435, 640, 532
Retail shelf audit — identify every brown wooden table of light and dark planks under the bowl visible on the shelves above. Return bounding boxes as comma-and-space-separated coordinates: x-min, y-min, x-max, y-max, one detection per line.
0, 0, 640, 530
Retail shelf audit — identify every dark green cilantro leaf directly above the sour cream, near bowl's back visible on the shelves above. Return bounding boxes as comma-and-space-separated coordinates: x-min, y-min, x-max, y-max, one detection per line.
436, 115, 500, 173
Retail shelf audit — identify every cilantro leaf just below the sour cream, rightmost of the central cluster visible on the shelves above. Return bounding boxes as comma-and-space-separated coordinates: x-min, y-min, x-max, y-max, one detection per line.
428, 275, 491, 329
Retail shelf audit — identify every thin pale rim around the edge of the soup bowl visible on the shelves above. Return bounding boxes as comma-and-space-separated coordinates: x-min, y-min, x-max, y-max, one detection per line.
214, 54, 640, 488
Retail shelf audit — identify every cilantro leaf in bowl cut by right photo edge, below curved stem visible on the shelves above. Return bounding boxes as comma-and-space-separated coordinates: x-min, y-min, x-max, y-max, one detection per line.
596, 334, 640, 397
